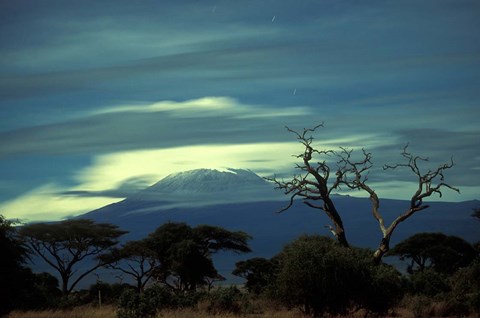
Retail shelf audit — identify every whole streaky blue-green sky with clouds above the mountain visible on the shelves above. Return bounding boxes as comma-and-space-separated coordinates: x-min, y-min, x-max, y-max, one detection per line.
0, 0, 480, 222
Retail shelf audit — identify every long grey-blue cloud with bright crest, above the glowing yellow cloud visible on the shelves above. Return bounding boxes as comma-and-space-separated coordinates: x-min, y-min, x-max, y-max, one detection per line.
0, 97, 310, 157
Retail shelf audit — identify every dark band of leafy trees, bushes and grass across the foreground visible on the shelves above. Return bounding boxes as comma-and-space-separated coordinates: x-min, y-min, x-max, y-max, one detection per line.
0, 207, 480, 318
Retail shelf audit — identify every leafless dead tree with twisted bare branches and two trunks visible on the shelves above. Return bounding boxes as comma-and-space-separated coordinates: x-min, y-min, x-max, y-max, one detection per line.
268, 124, 459, 263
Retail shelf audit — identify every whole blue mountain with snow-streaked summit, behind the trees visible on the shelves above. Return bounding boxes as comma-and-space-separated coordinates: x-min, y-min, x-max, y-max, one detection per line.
79, 169, 480, 284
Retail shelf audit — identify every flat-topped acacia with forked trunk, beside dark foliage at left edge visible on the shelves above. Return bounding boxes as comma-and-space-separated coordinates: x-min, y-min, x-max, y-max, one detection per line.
19, 219, 127, 295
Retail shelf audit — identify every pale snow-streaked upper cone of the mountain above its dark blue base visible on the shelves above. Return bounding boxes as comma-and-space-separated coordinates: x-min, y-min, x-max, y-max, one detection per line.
85, 168, 284, 217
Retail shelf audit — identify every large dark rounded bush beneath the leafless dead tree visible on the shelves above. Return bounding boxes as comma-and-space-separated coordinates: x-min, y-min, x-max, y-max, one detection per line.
276, 236, 401, 316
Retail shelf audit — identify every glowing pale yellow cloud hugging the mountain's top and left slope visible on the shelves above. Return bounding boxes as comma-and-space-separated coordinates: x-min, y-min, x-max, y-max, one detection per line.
1, 143, 296, 221
